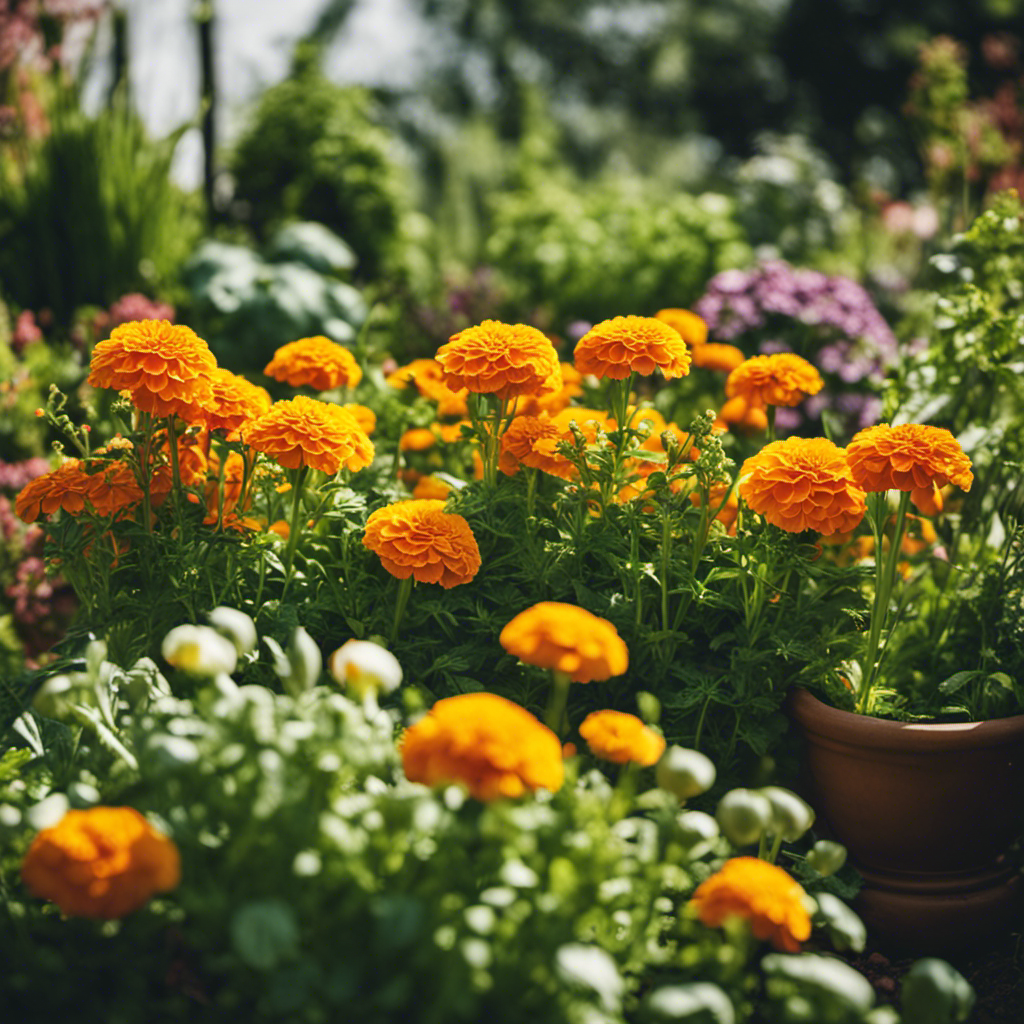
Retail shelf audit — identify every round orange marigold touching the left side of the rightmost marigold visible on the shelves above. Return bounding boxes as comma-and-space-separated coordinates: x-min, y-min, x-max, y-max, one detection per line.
739, 437, 867, 534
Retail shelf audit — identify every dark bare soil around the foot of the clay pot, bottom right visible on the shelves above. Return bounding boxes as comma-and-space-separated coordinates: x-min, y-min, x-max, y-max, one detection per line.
844, 933, 1024, 1024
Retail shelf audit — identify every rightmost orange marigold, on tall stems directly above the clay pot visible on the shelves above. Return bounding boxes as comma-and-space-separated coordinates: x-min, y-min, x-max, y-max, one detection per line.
846, 423, 974, 512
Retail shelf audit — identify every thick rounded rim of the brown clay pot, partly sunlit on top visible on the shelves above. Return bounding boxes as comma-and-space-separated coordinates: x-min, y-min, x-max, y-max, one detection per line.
786, 687, 1024, 752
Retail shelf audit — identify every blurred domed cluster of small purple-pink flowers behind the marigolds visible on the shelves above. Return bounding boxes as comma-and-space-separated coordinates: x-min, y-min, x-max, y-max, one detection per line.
693, 260, 898, 384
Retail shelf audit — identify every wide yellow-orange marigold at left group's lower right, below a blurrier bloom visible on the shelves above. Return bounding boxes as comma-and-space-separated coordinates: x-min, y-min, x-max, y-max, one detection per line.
242, 395, 374, 475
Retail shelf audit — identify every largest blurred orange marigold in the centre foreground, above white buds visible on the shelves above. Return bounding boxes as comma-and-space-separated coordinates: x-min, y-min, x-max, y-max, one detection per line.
401, 693, 564, 800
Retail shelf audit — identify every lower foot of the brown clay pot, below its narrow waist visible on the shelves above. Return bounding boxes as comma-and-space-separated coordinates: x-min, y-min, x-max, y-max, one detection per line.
853, 865, 1024, 956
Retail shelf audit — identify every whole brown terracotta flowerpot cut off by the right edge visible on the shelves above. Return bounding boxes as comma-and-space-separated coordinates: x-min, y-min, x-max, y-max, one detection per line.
788, 689, 1024, 954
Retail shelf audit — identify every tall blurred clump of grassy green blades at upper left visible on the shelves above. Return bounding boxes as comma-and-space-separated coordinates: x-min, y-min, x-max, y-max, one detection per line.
0, 82, 201, 325
